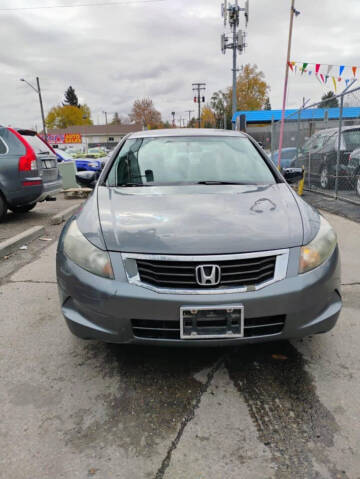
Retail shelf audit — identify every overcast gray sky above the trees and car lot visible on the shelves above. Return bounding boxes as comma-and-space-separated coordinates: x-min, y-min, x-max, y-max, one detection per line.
0, 0, 360, 127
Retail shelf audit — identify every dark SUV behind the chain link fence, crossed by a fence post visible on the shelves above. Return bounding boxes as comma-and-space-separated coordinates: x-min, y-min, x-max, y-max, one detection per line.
294, 126, 360, 189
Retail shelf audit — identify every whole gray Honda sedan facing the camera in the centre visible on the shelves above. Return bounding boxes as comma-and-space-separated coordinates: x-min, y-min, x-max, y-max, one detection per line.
57, 129, 342, 346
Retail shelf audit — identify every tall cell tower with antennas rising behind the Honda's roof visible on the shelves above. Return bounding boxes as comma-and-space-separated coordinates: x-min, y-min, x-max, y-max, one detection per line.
221, 0, 249, 129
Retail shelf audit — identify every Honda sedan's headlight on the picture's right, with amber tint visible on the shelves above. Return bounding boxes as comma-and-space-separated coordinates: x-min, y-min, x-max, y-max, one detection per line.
299, 216, 337, 273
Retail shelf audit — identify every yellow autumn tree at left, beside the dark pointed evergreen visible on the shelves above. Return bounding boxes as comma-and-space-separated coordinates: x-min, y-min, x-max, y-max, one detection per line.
45, 105, 93, 128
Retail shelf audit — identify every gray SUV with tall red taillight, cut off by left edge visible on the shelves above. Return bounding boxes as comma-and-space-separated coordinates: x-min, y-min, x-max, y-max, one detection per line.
0, 126, 62, 220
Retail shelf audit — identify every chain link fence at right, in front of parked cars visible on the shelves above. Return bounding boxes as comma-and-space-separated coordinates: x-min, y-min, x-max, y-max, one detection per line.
247, 87, 360, 205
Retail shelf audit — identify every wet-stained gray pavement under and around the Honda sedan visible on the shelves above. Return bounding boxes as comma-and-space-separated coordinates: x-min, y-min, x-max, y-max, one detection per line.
0, 214, 360, 479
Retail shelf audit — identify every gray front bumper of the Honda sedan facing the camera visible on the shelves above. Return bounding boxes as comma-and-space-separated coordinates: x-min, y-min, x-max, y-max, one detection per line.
57, 248, 342, 346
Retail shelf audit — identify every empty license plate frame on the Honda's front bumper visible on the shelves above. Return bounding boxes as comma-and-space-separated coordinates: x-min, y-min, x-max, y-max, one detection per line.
180, 304, 244, 339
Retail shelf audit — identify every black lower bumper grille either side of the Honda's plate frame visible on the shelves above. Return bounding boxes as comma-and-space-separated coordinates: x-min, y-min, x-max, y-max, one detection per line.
132, 314, 286, 340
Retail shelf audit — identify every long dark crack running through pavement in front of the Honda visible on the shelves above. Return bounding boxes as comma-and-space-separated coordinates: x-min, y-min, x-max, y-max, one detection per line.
154, 356, 225, 479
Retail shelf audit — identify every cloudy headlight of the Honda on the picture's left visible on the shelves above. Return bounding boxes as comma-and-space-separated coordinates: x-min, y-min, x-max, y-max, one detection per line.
64, 220, 114, 279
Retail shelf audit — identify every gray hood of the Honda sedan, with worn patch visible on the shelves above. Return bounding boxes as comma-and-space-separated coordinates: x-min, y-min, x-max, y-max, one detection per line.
97, 183, 303, 254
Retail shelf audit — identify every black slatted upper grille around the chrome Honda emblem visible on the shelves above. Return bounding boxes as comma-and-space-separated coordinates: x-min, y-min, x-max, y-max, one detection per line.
136, 255, 276, 289
